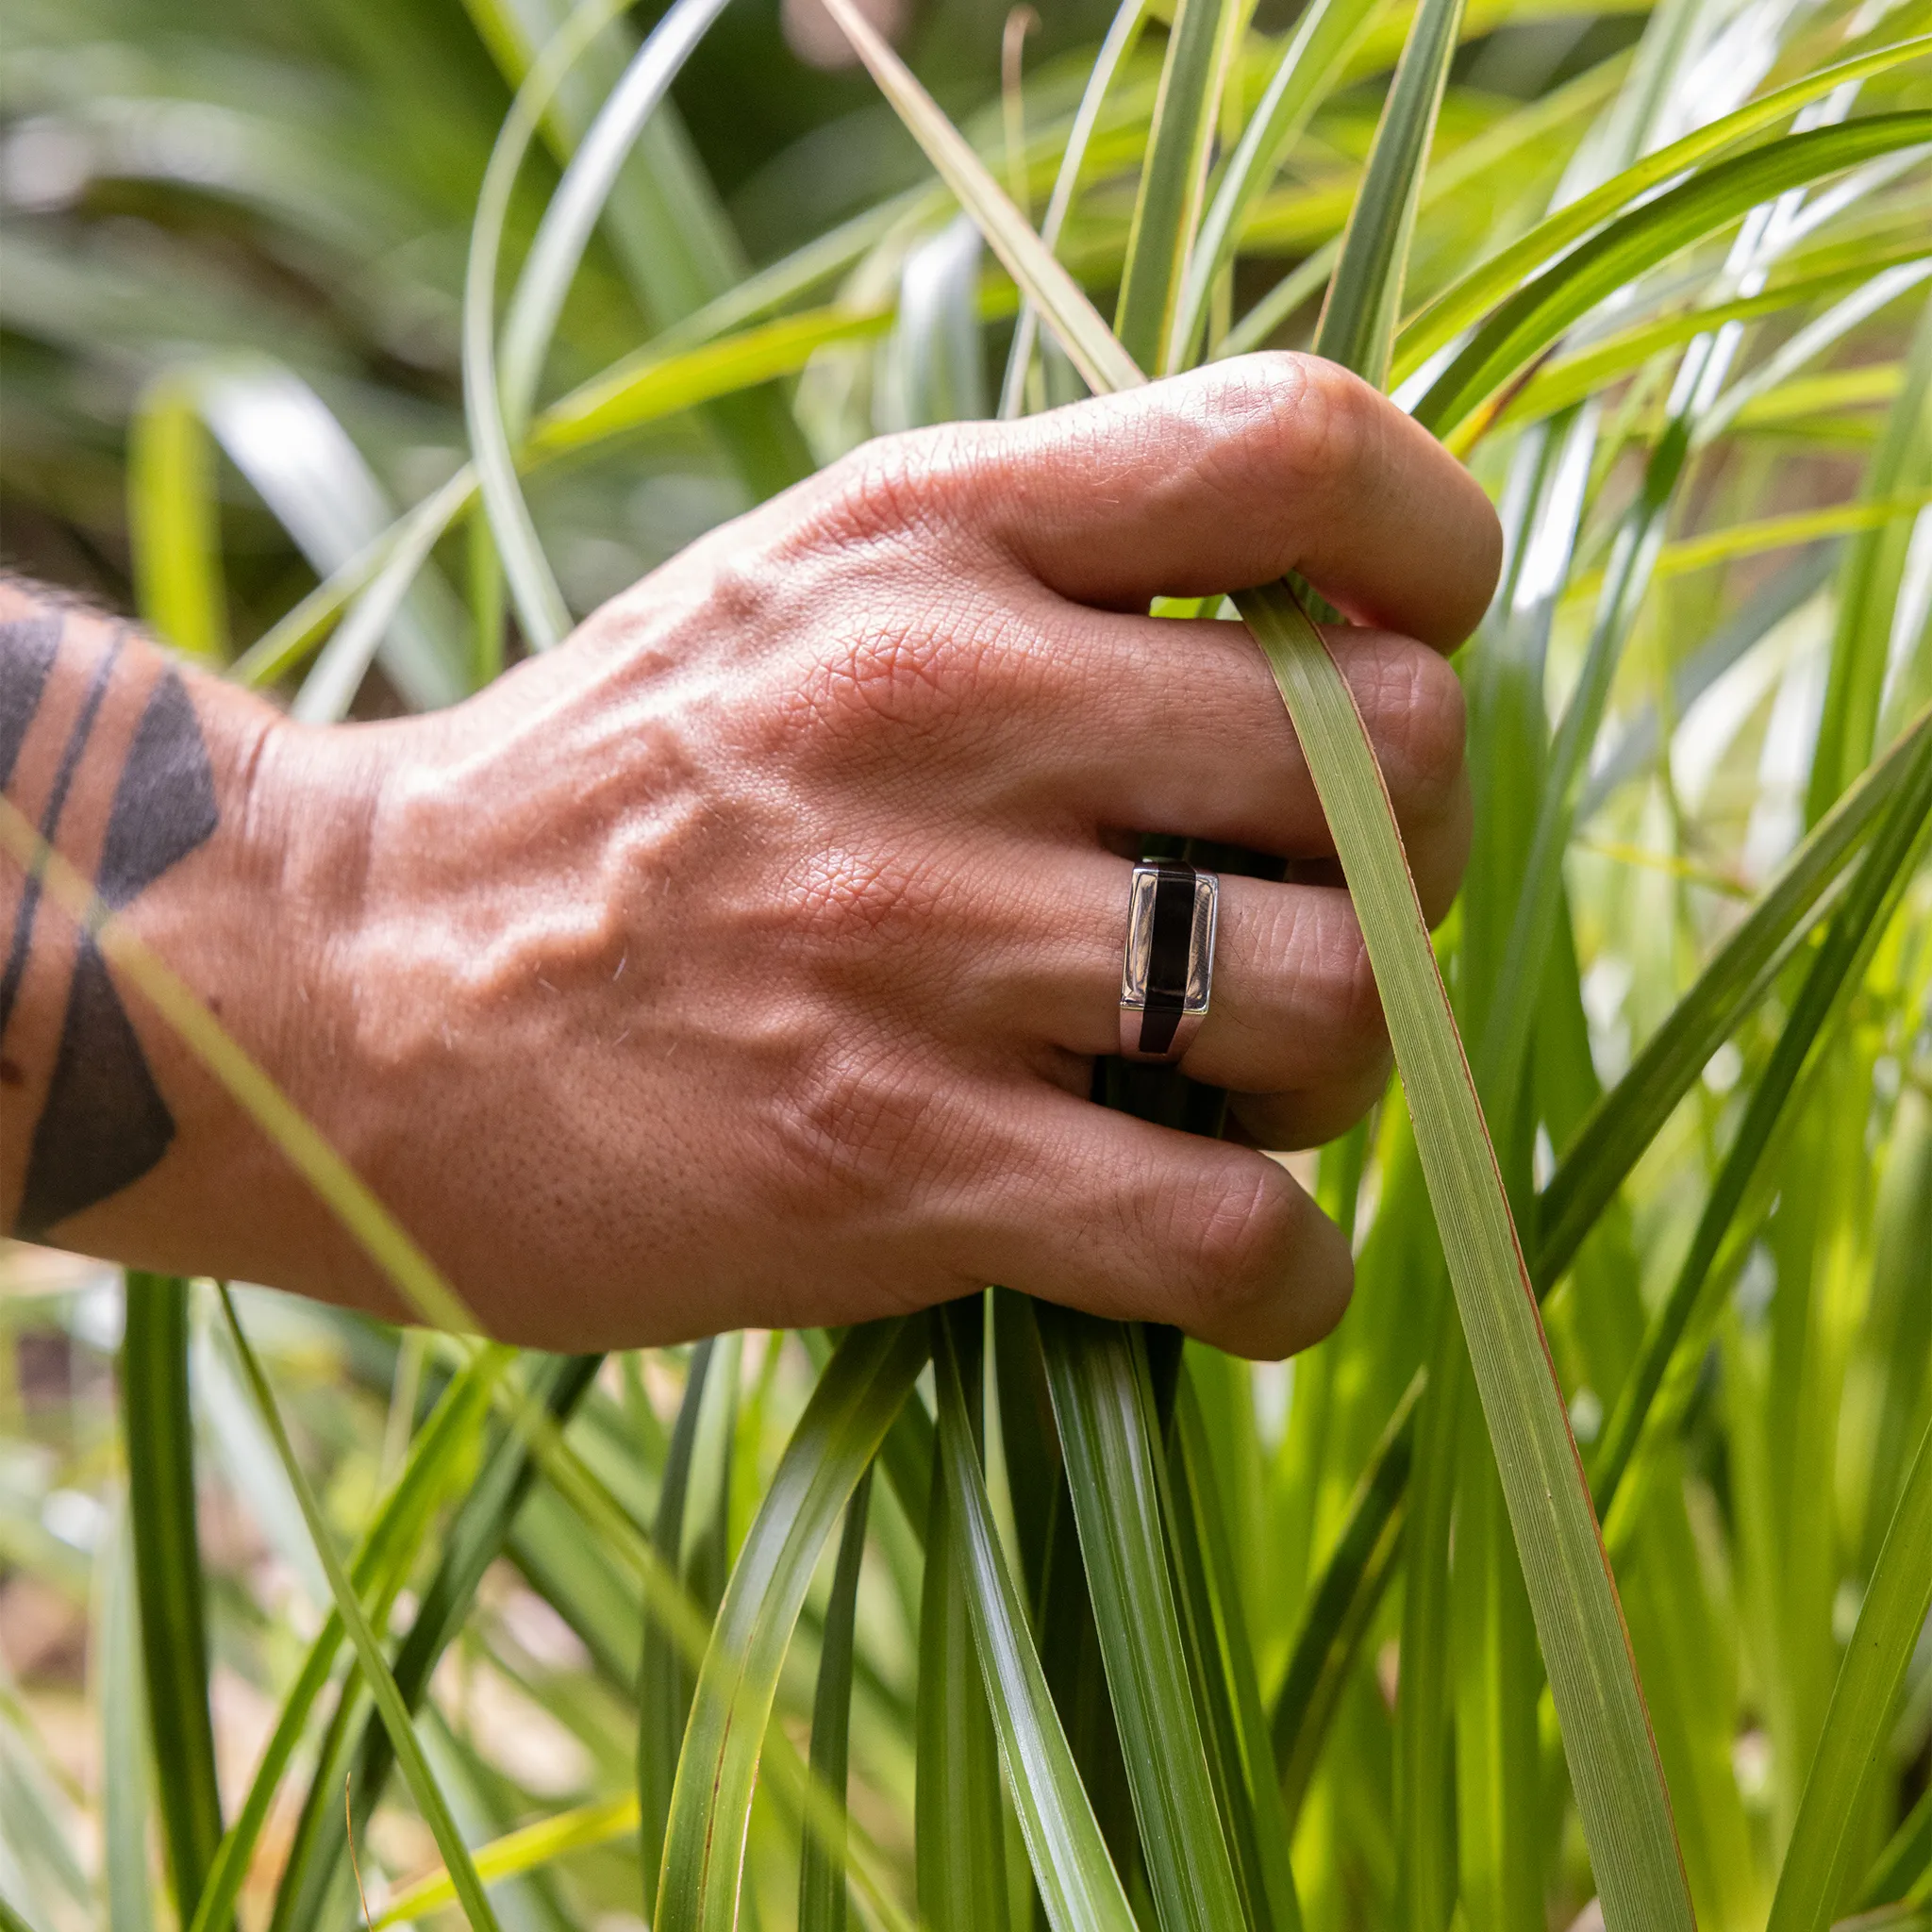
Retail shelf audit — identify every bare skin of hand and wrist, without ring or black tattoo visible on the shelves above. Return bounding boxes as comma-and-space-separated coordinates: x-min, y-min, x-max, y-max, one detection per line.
0, 356, 1499, 1357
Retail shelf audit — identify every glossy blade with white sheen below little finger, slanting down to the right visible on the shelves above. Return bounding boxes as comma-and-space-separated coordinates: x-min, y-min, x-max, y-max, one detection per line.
933, 1331, 1138, 1932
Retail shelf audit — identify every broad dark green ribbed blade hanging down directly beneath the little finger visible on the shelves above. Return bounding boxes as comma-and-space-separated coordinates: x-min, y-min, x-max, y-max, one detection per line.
1036, 1302, 1244, 1932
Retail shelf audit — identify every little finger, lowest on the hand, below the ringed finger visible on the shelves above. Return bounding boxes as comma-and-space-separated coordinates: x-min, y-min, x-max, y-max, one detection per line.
970, 1091, 1355, 1358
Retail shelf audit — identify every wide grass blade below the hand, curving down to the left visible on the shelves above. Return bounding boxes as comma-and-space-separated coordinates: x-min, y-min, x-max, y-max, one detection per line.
651, 1320, 927, 1932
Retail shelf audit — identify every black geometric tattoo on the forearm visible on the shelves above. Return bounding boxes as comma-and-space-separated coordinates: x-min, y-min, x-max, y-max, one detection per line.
0, 586, 220, 1241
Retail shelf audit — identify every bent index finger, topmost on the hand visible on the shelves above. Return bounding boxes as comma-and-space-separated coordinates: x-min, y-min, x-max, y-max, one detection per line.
927, 354, 1501, 649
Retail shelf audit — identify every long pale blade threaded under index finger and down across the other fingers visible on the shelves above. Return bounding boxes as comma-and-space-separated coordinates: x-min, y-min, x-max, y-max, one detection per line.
829, 0, 1700, 1932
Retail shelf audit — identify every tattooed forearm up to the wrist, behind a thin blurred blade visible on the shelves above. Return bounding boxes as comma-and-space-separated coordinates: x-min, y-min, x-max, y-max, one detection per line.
0, 581, 388, 1291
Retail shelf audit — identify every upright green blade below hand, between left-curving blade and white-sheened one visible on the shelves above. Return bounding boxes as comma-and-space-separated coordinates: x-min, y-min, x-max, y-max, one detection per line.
914, 1294, 1008, 1932
